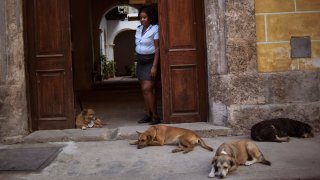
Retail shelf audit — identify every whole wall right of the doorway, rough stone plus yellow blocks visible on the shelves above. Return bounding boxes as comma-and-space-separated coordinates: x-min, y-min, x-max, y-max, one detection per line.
205, 0, 320, 134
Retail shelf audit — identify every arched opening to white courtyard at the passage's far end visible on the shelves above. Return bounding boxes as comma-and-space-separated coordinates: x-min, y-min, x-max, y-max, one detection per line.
98, 5, 140, 81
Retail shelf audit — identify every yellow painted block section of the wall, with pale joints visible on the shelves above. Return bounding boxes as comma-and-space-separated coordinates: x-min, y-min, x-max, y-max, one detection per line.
255, 0, 320, 72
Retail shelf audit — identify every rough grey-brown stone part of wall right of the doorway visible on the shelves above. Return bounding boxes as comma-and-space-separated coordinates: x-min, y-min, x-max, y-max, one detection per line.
205, 0, 320, 134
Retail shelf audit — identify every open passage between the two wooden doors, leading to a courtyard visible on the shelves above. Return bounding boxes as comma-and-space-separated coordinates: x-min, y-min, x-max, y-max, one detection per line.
71, 0, 162, 128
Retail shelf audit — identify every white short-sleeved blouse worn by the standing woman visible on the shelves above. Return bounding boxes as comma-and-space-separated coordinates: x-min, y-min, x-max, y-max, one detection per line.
135, 25, 159, 54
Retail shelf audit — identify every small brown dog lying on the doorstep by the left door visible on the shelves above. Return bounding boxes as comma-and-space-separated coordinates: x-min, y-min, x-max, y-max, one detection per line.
76, 109, 105, 130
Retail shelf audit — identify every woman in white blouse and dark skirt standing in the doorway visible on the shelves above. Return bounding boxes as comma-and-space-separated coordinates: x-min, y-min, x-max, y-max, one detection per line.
135, 6, 160, 124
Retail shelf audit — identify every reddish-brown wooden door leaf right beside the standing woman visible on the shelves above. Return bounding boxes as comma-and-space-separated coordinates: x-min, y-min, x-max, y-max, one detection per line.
158, 0, 208, 123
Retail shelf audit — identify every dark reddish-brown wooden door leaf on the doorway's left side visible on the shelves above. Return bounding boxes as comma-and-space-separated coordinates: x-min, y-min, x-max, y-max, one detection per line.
24, 0, 74, 130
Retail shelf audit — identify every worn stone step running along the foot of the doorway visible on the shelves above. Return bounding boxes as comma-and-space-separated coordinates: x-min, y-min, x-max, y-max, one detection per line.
23, 122, 232, 143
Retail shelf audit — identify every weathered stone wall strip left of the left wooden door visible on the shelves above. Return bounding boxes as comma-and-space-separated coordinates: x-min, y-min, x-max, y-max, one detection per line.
0, 0, 28, 141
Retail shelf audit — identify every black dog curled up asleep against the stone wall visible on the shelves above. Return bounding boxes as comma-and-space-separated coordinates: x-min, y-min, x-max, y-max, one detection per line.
251, 118, 314, 142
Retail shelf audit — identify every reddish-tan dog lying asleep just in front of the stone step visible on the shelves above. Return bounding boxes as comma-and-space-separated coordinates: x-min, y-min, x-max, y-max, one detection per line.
130, 125, 213, 153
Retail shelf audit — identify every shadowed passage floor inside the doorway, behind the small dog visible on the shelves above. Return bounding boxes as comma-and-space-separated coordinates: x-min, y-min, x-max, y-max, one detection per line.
77, 82, 162, 128
